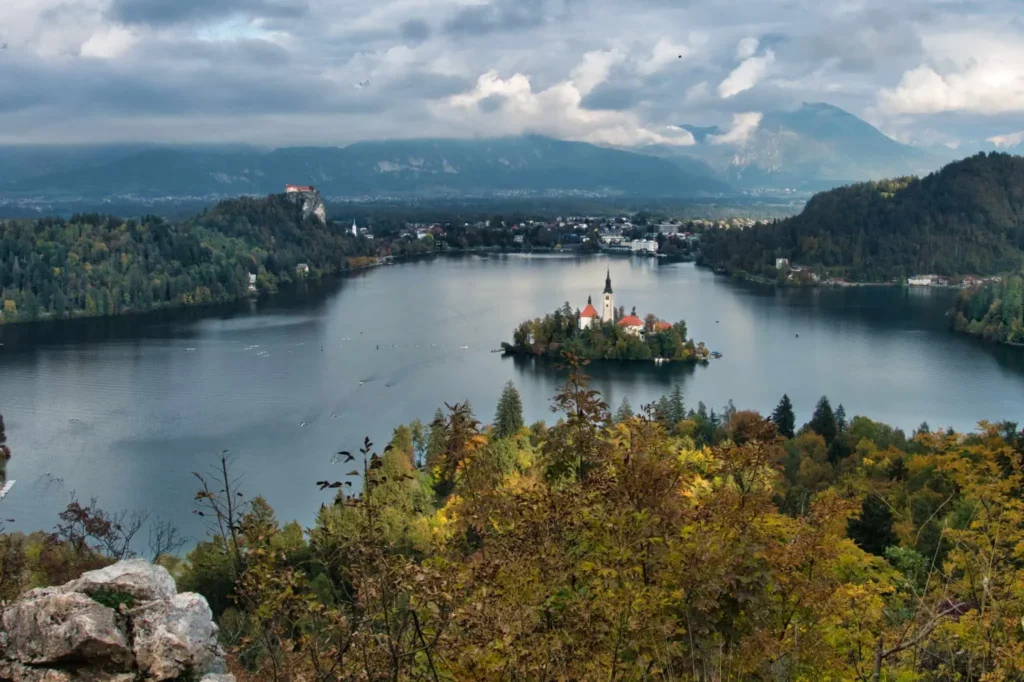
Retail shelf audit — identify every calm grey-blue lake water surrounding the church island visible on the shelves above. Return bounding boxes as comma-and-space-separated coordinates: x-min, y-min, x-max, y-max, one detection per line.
0, 251, 1024, 537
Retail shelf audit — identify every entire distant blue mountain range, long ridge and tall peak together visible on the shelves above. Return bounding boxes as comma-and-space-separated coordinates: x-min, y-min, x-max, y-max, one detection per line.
0, 103, 999, 205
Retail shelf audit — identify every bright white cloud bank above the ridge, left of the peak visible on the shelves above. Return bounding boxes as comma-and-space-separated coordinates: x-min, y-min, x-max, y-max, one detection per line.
431, 52, 694, 146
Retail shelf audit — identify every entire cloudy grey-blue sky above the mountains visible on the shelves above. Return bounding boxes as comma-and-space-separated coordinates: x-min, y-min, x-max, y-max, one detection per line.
0, 0, 1024, 148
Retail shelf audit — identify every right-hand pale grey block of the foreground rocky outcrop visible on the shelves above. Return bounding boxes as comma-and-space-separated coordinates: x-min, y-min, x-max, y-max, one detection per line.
128, 593, 221, 680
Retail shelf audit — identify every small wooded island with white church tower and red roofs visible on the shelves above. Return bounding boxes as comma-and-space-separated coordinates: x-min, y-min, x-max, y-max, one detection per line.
502, 271, 711, 363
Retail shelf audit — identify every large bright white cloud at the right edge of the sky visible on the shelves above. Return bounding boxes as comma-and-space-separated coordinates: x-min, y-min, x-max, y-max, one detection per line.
878, 32, 1024, 115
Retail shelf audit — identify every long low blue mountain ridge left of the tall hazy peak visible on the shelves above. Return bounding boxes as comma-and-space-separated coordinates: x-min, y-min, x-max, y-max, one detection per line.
0, 136, 729, 199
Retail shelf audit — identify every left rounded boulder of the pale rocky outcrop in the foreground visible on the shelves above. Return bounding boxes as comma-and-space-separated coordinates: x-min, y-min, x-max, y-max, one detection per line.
0, 588, 132, 671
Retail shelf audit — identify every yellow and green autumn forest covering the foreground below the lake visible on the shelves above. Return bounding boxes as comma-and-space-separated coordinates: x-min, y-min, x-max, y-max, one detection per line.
0, 366, 1024, 682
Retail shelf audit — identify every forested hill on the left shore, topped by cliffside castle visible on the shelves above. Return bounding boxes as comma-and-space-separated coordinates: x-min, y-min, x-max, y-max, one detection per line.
0, 188, 387, 323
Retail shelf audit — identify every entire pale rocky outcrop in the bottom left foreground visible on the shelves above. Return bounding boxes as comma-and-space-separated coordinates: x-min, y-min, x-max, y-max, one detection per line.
0, 560, 234, 682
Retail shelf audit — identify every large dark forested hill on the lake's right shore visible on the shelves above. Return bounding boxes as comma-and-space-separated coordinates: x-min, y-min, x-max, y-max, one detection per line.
701, 154, 1024, 281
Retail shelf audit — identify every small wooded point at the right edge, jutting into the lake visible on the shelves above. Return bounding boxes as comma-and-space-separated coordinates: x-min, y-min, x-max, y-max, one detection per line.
952, 274, 1024, 345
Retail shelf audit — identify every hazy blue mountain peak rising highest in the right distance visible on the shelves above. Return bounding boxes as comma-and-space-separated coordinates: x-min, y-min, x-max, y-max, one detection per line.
665, 103, 940, 190
